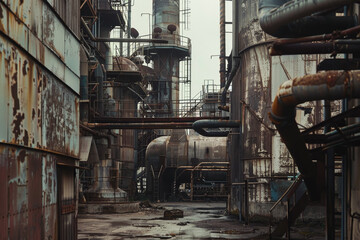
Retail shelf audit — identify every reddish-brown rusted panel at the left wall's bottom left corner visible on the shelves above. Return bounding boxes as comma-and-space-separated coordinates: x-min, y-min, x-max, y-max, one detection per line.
2, 148, 44, 239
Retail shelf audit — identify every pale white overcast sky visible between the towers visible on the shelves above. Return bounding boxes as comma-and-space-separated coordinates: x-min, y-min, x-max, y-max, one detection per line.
131, 0, 231, 96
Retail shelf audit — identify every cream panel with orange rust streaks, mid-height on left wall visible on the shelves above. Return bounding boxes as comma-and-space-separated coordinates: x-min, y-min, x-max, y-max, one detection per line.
5, 41, 41, 147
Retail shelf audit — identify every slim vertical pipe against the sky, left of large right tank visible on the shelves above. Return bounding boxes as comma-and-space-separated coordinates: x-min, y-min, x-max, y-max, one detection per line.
220, 0, 226, 88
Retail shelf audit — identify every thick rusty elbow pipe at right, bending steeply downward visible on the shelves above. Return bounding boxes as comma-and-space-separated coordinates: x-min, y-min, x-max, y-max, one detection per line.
270, 70, 360, 199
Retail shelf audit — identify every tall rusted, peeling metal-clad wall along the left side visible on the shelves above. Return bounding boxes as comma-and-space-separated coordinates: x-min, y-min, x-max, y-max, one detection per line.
0, 0, 80, 239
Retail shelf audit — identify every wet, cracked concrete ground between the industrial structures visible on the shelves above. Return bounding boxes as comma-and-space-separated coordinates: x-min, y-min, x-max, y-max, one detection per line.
78, 202, 324, 240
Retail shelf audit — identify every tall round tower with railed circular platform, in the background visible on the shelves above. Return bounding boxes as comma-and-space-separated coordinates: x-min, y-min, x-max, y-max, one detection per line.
144, 0, 191, 117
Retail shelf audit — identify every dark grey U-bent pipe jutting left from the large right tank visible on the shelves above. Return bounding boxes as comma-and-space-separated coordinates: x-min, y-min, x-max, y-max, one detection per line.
192, 120, 240, 137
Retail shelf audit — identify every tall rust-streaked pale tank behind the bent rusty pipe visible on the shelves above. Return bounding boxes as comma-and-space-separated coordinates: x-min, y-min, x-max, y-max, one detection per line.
229, 1, 322, 218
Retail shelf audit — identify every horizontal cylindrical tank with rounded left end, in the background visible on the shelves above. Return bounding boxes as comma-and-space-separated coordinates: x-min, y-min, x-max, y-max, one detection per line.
145, 131, 227, 199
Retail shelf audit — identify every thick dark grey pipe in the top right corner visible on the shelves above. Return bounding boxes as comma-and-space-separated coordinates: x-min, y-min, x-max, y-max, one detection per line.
259, 0, 360, 37
